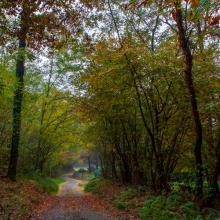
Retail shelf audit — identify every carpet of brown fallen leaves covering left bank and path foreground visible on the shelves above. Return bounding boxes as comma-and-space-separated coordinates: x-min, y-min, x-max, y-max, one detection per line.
0, 179, 140, 220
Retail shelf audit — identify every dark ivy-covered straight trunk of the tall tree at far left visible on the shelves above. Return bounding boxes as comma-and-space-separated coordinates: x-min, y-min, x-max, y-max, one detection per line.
7, 37, 26, 181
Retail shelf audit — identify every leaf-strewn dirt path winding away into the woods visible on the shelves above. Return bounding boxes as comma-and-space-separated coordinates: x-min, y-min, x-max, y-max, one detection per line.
31, 174, 139, 220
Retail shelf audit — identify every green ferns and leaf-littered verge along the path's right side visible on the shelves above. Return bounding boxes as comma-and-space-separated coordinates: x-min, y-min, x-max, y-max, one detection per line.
84, 179, 220, 220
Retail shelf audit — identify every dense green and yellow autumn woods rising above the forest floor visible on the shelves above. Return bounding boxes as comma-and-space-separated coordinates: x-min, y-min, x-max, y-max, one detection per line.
0, 0, 220, 207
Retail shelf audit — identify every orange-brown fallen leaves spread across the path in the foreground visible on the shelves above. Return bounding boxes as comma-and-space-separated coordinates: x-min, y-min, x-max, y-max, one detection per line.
31, 191, 140, 220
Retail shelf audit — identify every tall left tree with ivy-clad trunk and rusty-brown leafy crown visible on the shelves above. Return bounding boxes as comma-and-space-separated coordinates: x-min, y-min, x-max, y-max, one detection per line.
0, 0, 83, 181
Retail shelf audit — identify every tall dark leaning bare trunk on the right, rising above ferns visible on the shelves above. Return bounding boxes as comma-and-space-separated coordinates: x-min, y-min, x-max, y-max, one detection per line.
176, 5, 203, 198
